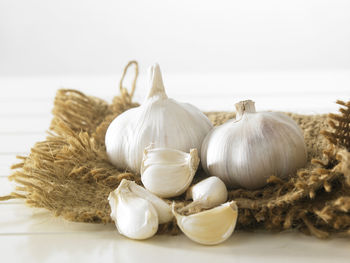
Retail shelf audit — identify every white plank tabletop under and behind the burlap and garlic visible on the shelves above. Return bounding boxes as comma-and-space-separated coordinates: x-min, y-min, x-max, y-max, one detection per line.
0, 71, 350, 263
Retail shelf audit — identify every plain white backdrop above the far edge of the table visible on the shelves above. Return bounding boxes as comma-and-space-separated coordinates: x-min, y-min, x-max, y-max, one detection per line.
0, 0, 350, 75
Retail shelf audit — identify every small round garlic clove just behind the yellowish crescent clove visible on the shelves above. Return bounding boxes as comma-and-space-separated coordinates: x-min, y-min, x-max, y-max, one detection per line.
186, 176, 228, 208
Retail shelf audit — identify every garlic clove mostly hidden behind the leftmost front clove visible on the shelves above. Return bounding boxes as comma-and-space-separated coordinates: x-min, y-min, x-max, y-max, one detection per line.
128, 178, 174, 224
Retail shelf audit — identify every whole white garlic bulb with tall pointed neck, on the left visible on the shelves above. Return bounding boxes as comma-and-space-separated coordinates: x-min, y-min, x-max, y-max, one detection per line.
105, 64, 212, 173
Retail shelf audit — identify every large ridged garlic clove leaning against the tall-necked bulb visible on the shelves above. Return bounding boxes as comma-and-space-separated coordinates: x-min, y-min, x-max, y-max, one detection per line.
141, 144, 199, 198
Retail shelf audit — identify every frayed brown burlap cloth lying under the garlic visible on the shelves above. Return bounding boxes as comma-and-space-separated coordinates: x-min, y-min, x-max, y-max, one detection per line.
0, 65, 350, 238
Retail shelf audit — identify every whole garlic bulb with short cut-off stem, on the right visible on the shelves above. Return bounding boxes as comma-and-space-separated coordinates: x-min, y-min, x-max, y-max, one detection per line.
201, 100, 307, 189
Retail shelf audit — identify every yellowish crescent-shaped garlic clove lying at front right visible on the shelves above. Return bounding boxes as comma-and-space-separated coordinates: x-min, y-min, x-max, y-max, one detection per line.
173, 201, 238, 248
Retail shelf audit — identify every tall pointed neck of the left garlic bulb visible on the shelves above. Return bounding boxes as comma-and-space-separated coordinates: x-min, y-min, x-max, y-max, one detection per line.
146, 63, 168, 99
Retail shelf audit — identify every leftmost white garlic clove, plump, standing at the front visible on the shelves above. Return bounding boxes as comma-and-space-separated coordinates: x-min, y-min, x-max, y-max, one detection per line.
108, 182, 158, 239
